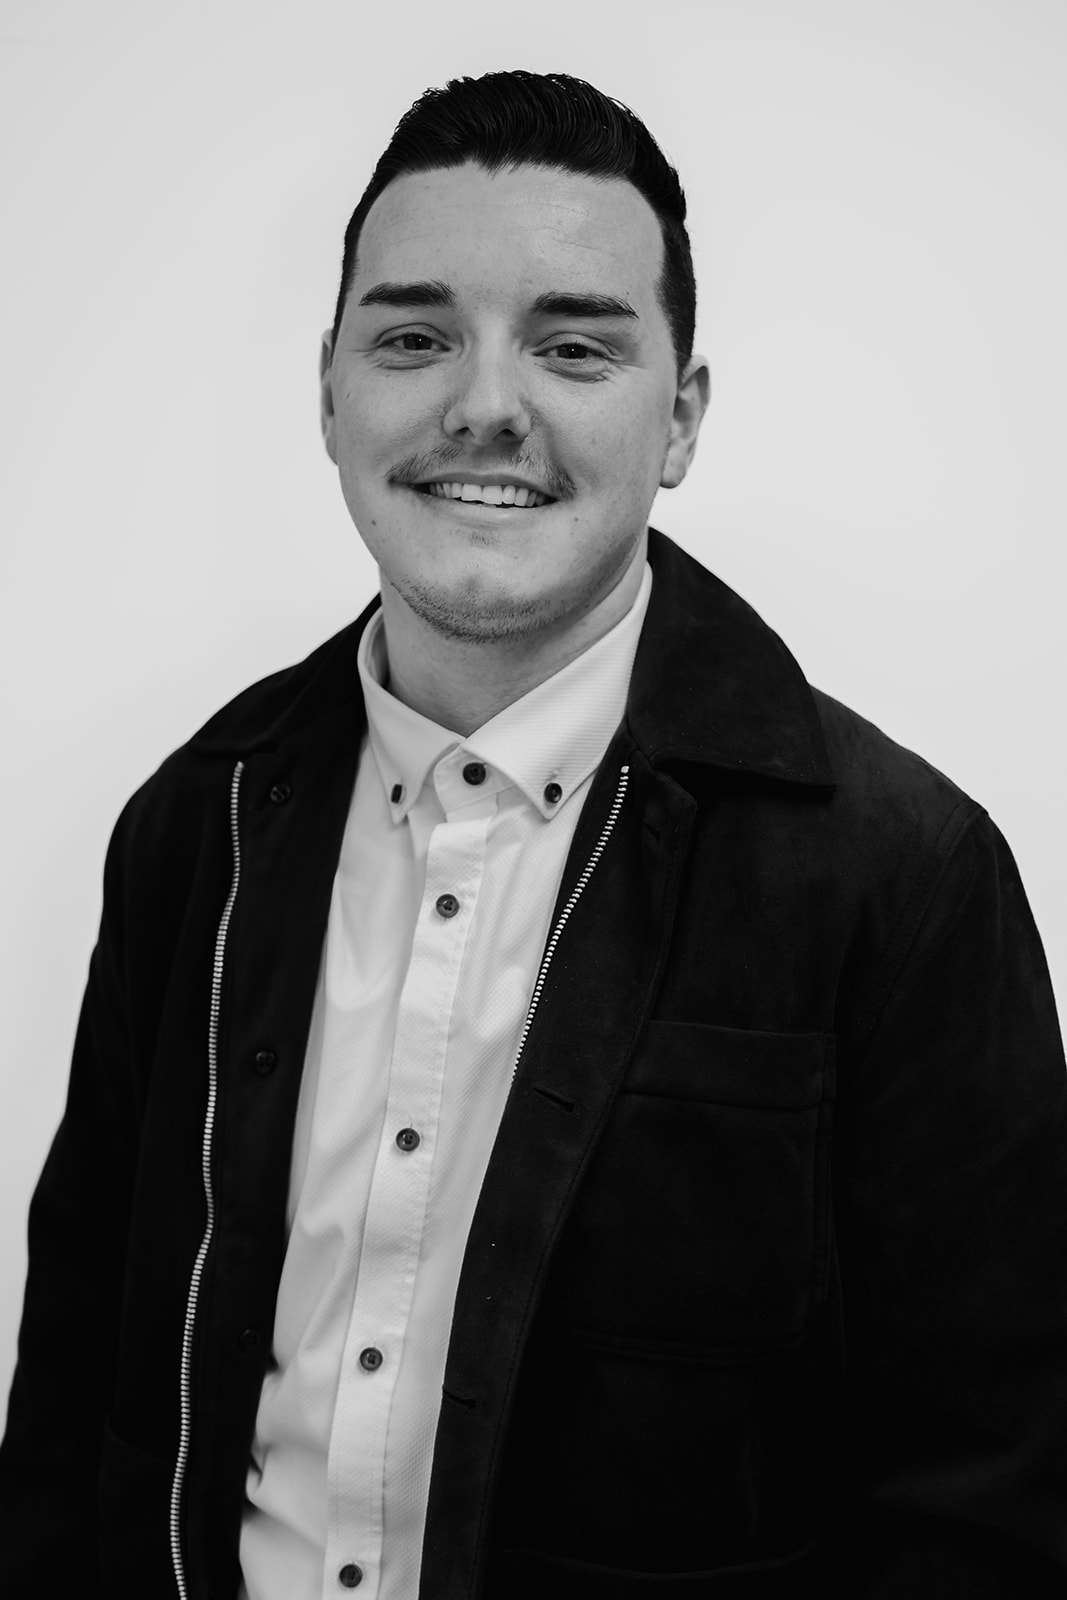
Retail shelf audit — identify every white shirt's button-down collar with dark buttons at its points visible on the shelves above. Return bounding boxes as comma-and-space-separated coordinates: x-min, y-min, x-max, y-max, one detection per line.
357, 563, 653, 822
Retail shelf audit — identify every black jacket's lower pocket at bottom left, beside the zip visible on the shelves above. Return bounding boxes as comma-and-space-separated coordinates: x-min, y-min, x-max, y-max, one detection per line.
98, 1422, 176, 1600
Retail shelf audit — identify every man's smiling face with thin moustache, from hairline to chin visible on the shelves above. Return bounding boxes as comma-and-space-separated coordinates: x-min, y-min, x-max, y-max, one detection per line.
323, 163, 707, 640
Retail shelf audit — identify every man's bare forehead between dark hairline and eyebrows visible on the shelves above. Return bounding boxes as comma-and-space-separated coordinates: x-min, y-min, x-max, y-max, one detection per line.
354, 162, 664, 312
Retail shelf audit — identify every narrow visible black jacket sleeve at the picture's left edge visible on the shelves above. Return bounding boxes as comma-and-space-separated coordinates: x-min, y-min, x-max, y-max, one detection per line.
0, 806, 138, 1600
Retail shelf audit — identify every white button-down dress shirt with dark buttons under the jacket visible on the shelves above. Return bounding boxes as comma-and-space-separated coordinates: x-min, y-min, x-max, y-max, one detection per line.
240, 566, 651, 1600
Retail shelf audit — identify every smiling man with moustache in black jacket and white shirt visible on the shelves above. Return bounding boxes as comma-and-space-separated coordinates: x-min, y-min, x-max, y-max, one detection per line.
0, 74, 1067, 1600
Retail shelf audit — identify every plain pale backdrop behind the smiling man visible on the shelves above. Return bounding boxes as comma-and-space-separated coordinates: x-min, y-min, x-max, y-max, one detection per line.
0, 0, 1067, 1390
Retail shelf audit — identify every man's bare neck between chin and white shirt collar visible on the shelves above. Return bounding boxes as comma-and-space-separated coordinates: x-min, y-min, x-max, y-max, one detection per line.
382, 538, 648, 738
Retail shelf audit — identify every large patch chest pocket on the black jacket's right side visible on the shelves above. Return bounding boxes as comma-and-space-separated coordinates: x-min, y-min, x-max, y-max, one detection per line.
549, 1021, 833, 1360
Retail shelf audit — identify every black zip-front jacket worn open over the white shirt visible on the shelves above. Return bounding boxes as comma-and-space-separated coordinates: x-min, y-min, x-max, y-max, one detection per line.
0, 534, 1067, 1600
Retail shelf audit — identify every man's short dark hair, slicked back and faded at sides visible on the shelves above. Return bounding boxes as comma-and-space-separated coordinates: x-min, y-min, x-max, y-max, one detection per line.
331, 72, 696, 371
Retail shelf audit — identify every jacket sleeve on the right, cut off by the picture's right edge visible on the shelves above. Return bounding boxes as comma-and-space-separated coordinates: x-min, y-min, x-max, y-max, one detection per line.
835, 811, 1067, 1600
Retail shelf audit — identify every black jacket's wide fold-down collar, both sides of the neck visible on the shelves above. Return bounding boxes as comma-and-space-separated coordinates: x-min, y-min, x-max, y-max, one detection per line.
190, 528, 833, 787
